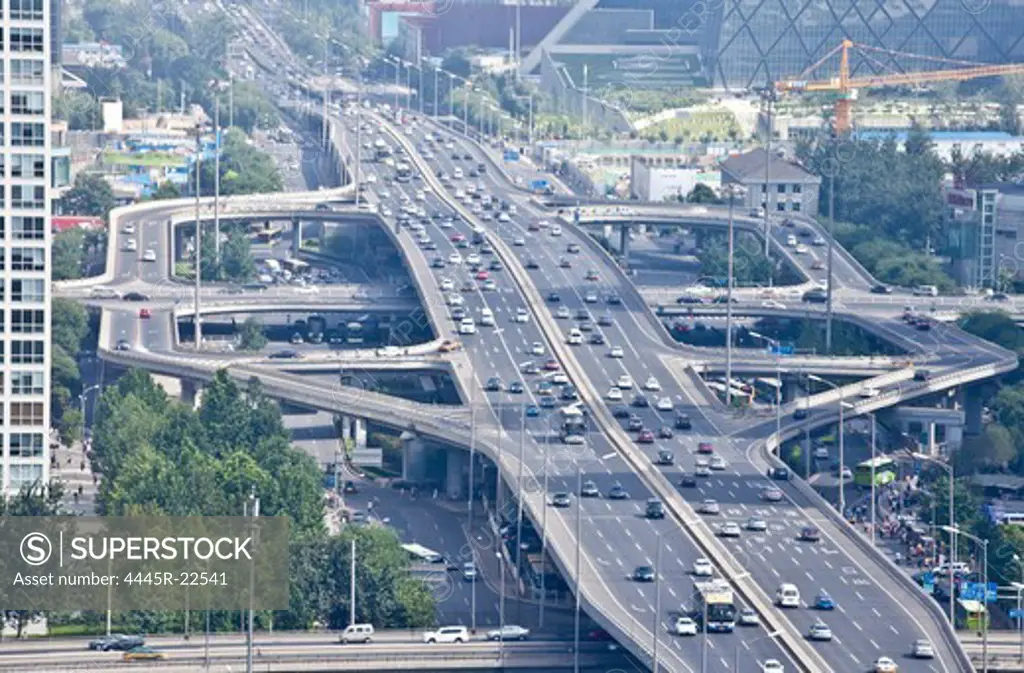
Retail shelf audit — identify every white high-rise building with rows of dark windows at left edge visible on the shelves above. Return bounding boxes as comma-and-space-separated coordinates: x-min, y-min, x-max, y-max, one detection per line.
0, 0, 51, 493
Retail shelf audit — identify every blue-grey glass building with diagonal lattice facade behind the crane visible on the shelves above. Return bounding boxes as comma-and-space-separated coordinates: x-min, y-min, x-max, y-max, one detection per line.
702, 0, 1024, 88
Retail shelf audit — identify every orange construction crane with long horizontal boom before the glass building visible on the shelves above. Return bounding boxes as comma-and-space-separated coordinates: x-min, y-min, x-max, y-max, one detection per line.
775, 40, 1024, 134
